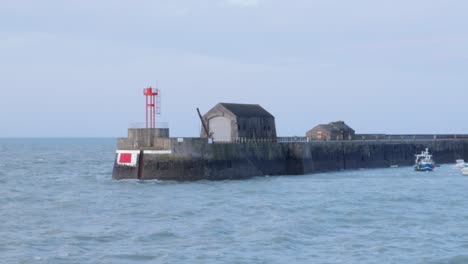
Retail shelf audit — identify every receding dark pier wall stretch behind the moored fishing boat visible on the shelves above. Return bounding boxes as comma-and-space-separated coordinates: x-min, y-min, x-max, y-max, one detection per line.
303, 140, 468, 174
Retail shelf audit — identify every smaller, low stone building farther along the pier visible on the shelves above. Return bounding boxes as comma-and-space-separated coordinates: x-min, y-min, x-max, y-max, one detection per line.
306, 121, 355, 141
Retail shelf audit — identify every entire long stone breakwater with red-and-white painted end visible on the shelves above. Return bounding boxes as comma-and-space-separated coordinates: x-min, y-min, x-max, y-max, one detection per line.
112, 129, 468, 181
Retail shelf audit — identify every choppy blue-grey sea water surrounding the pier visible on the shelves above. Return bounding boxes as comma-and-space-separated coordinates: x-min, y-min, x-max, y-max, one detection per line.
0, 139, 468, 264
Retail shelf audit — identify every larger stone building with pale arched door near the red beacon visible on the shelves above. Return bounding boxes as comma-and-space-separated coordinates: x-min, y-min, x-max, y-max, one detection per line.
201, 103, 276, 142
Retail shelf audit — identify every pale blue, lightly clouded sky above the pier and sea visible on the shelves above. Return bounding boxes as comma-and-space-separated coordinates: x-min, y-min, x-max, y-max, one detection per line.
0, 0, 468, 137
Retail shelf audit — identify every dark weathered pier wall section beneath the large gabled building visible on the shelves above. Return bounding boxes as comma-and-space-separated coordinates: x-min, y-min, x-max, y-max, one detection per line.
137, 139, 294, 181
